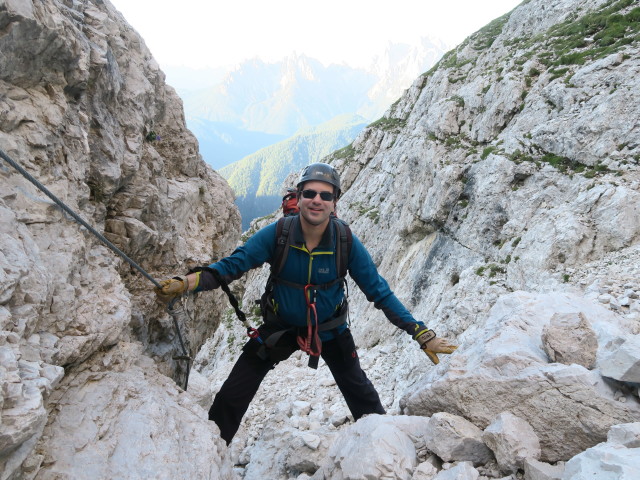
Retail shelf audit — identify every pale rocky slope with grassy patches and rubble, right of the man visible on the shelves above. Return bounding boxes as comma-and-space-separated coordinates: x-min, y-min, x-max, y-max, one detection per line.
199, 0, 640, 480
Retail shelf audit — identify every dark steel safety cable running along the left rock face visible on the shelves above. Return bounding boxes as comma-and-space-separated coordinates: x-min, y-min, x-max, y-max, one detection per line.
0, 150, 192, 390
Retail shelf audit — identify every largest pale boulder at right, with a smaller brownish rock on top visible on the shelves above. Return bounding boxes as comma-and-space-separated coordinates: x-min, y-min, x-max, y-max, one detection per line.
402, 292, 640, 462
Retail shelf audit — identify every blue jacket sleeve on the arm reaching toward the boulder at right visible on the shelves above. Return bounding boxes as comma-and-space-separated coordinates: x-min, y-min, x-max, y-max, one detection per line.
349, 235, 425, 335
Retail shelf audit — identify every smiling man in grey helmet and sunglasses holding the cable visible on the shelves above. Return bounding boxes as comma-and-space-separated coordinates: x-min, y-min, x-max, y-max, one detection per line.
156, 163, 457, 444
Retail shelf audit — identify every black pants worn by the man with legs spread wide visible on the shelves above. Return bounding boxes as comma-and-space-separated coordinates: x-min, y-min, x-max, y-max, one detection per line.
209, 329, 385, 445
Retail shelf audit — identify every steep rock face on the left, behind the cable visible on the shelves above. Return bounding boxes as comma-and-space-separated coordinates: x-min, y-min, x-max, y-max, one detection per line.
0, 0, 240, 479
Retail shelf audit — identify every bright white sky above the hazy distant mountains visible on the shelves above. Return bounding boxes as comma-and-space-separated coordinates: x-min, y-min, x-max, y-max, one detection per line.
111, 0, 521, 68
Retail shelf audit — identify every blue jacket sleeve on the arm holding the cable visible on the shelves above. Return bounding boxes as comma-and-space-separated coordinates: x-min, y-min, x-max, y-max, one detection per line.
194, 223, 276, 292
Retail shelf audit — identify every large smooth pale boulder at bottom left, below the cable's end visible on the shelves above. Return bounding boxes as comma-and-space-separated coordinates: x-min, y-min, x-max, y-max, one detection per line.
33, 342, 236, 480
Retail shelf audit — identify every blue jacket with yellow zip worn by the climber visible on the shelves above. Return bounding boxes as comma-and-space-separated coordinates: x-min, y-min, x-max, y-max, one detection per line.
196, 218, 424, 341
